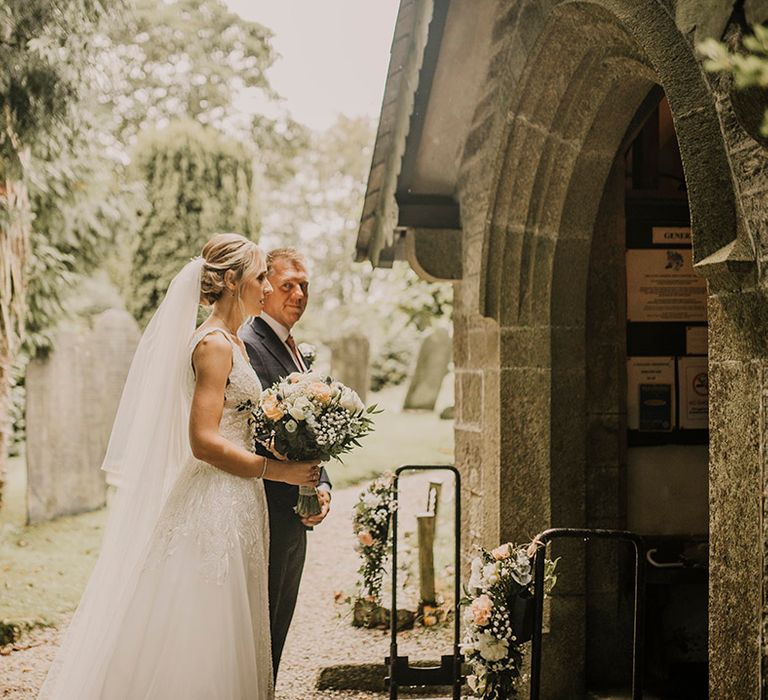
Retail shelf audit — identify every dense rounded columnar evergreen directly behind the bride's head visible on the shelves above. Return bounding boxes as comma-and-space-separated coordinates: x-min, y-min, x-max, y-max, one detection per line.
128, 121, 259, 324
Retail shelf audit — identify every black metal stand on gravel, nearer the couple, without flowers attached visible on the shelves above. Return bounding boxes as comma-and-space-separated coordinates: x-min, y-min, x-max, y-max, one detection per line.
384, 464, 464, 700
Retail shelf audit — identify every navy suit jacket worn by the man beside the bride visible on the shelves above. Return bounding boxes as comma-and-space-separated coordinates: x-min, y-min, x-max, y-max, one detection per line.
239, 316, 331, 516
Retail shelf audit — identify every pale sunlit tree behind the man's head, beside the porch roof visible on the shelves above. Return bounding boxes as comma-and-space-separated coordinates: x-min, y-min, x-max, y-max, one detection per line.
263, 116, 452, 386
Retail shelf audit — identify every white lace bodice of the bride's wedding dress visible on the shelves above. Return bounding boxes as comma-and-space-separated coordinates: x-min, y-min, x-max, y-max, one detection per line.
190, 328, 261, 450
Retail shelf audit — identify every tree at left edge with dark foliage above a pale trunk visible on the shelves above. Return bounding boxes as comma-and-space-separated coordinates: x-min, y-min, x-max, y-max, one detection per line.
0, 0, 117, 499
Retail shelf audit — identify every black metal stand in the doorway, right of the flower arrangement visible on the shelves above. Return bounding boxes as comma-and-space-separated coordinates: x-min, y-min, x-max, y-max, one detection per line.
531, 528, 645, 700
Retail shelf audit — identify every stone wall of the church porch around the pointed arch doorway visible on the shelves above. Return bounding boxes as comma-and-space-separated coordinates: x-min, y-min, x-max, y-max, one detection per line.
444, 0, 768, 698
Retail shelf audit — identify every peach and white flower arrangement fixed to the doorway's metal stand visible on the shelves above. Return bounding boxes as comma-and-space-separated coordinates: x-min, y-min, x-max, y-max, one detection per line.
461, 543, 557, 700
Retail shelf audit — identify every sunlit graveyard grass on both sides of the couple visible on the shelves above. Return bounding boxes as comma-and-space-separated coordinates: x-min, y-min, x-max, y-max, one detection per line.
0, 382, 453, 632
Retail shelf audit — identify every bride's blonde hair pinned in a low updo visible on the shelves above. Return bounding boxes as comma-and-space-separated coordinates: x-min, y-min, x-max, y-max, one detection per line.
200, 233, 263, 306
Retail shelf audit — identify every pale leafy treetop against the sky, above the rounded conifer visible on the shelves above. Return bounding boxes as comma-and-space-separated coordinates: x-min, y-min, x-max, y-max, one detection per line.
103, 0, 277, 144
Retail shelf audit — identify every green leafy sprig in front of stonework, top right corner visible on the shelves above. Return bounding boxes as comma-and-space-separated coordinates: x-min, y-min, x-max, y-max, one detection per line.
698, 24, 768, 136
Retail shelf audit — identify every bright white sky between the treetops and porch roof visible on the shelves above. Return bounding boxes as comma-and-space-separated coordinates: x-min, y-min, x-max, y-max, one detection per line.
225, 0, 400, 129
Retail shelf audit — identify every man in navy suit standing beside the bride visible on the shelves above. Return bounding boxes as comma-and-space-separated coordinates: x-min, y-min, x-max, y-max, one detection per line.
240, 248, 331, 678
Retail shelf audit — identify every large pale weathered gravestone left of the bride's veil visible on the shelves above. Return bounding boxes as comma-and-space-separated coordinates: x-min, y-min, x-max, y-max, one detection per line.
26, 309, 139, 523
